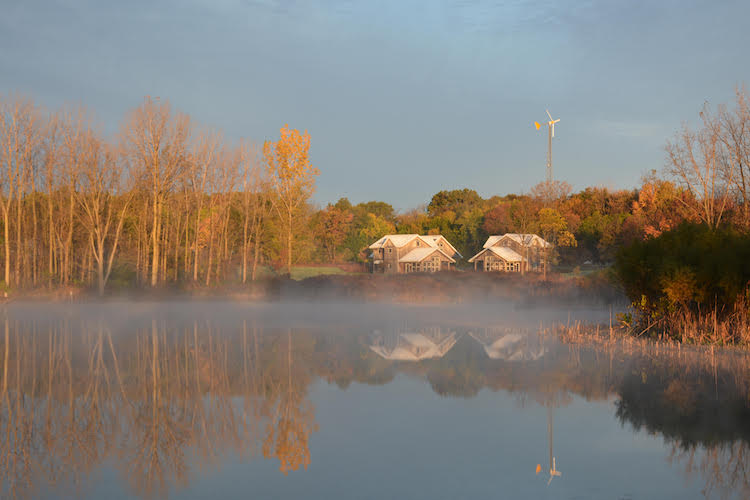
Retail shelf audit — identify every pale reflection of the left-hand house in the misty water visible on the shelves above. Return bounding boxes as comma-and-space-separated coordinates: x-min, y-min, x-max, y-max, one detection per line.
369, 328, 458, 361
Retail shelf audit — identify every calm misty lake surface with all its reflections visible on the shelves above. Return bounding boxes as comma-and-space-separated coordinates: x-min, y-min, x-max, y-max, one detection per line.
0, 303, 750, 499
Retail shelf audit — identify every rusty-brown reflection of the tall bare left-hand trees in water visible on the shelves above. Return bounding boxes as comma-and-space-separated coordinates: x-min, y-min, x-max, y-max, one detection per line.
0, 319, 316, 498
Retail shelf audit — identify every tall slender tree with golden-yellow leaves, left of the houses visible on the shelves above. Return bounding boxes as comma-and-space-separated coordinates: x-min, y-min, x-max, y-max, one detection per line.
263, 125, 320, 274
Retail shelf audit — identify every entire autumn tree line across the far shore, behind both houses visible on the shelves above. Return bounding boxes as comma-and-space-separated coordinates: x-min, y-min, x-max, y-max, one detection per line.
0, 89, 750, 292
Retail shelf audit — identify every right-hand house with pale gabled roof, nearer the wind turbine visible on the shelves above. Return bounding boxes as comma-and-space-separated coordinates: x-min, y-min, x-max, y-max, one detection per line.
469, 233, 552, 273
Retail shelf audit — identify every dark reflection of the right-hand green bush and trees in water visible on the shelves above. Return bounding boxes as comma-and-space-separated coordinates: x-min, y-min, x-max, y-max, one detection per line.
617, 351, 750, 498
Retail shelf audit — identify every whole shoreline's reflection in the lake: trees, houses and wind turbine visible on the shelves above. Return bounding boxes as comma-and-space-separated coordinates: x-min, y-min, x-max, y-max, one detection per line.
0, 310, 750, 498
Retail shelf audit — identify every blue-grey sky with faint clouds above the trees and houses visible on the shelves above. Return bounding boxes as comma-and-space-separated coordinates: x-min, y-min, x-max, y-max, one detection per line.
0, 0, 750, 210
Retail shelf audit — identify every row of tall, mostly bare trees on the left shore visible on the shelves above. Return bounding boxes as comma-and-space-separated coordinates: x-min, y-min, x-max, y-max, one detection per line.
0, 95, 318, 293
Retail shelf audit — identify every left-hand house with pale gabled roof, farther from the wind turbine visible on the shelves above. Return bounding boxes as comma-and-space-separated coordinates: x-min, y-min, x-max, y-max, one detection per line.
369, 234, 463, 273
